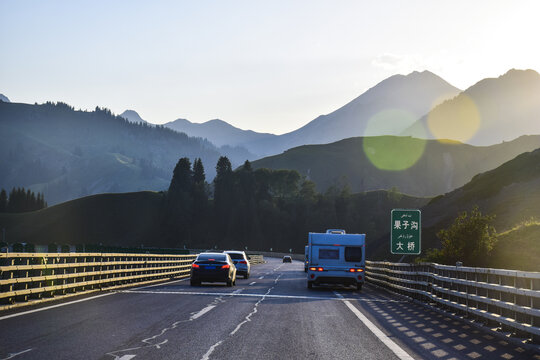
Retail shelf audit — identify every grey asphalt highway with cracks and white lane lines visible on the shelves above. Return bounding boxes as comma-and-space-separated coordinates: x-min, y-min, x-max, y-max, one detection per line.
0, 258, 540, 360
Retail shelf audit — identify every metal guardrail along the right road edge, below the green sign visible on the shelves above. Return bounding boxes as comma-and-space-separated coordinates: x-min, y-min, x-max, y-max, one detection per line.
366, 261, 540, 343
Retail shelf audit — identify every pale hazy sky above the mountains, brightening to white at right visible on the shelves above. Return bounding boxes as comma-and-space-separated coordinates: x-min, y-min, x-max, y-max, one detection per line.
0, 0, 540, 133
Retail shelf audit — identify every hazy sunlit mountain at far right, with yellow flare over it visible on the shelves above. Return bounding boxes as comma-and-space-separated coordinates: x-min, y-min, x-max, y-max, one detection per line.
401, 69, 540, 146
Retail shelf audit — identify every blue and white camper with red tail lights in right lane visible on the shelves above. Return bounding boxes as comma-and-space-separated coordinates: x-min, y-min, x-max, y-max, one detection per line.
307, 229, 366, 290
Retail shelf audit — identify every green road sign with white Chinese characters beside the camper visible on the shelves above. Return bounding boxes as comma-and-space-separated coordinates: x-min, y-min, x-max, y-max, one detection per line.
390, 209, 422, 255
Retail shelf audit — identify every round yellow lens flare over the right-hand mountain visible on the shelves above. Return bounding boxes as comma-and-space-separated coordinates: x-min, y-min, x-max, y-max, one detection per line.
427, 94, 481, 142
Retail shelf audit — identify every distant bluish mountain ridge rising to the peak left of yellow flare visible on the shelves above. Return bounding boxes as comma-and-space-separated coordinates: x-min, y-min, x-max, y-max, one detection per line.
157, 71, 461, 157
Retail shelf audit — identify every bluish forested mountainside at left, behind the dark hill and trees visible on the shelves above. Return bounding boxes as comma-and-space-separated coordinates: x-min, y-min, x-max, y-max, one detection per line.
0, 102, 247, 205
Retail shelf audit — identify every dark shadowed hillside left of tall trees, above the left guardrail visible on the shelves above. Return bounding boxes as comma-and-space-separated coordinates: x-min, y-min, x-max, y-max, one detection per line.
0, 191, 165, 246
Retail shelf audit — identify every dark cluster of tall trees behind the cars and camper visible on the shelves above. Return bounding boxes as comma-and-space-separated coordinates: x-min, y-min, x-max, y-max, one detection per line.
160, 157, 394, 252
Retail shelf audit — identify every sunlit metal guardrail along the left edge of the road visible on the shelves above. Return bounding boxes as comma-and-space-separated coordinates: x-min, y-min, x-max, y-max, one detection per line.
0, 253, 196, 310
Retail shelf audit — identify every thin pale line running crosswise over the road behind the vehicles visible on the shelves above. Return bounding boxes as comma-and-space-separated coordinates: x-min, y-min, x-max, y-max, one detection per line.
121, 290, 408, 303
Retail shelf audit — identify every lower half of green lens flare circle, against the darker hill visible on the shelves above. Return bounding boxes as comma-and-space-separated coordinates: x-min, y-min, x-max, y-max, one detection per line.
363, 136, 426, 171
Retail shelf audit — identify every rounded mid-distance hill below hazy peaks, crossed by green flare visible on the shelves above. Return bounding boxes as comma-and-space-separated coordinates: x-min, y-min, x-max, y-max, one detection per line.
252, 136, 540, 196
